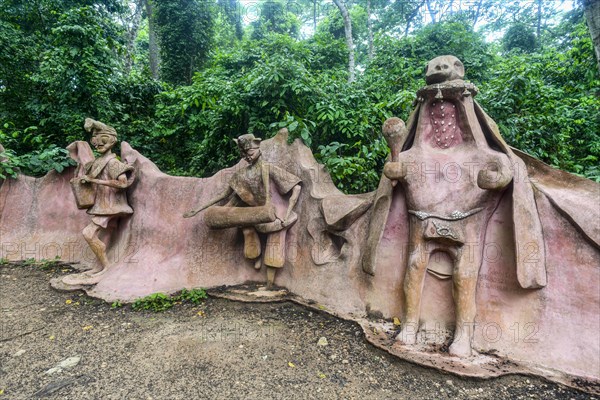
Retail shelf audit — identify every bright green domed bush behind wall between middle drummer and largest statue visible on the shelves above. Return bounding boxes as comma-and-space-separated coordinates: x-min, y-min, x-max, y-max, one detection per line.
145, 34, 412, 192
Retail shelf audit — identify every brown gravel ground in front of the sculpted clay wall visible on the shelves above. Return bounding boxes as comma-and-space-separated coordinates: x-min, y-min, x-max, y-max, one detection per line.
0, 265, 596, 400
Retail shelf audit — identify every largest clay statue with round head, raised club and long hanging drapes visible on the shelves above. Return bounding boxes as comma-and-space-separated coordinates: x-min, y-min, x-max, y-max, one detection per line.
363, 56, 546, 357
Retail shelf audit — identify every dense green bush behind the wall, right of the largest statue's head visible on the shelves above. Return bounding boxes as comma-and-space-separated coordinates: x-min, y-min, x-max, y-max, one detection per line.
480, 26, 600, 180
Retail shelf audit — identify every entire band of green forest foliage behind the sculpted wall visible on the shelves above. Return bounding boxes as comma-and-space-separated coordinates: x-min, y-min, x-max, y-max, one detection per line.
0, 0, 600, 188
